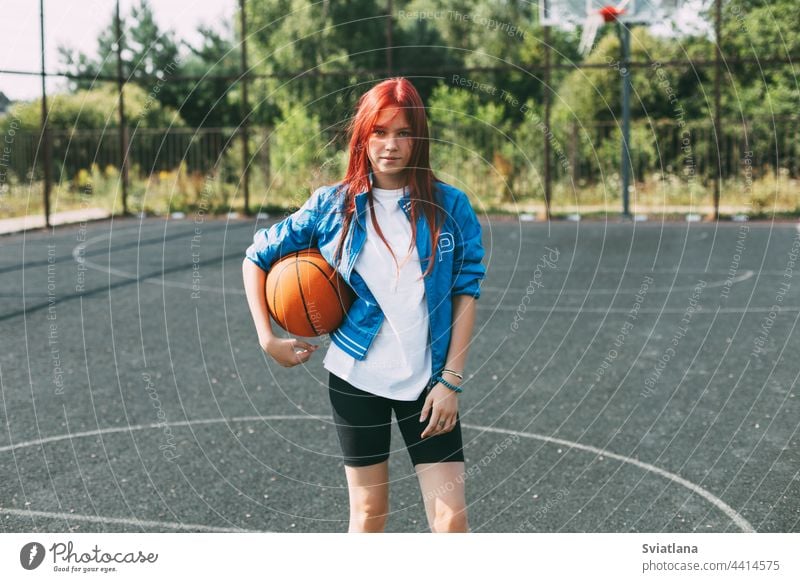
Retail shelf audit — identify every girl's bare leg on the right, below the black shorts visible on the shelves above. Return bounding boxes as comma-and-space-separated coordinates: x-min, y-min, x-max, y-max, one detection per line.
415, 461, 469, 533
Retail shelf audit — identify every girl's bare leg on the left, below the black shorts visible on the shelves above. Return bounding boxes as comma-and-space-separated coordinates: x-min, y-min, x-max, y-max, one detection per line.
344, 459, 389, 533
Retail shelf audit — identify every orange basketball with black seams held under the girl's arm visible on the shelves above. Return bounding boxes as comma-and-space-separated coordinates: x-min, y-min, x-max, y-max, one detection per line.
266, 249, 353, 337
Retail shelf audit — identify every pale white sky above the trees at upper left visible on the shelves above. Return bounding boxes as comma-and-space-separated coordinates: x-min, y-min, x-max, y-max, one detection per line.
0, 0, 238, 100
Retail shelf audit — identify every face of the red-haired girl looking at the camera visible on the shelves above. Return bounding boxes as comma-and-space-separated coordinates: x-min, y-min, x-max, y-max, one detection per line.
367, 107, 412, 189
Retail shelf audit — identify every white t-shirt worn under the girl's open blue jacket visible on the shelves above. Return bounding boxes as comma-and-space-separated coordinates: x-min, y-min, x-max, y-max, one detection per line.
323, 187, 432, 400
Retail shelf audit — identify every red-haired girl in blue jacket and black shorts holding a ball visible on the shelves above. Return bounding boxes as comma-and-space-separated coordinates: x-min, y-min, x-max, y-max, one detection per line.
243, 78, 483, 532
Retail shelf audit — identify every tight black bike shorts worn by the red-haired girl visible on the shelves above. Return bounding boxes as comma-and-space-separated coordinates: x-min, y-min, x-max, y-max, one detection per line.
328, 372, 464, 467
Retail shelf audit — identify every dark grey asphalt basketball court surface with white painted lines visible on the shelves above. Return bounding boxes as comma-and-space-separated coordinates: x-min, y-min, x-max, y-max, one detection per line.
0, 216, 800, 532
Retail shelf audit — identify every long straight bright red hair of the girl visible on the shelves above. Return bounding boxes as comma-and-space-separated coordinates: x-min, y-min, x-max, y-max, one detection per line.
336, 77, 443, 277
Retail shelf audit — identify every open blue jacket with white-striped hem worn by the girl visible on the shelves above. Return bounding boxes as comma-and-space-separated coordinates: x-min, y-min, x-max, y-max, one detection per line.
245, 174, 486, 387
